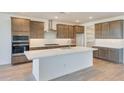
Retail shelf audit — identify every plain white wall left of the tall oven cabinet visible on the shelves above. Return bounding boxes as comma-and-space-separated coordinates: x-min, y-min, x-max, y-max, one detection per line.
0, 14, 11, 65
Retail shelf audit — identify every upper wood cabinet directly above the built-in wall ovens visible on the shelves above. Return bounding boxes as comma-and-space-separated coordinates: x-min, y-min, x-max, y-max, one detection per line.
11, 17, 30, 36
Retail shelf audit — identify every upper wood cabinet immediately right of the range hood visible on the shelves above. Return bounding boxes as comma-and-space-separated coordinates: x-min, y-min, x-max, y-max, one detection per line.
57, 24, 75, 39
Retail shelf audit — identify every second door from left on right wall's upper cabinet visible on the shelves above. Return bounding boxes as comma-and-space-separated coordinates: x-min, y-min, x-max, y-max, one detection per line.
101, 22, 109, 39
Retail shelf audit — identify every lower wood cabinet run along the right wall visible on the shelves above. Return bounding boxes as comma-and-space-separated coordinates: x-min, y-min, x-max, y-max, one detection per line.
93, 47, 123, 64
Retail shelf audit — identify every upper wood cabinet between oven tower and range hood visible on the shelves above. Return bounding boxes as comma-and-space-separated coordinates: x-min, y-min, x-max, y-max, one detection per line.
30, 21, 44, 38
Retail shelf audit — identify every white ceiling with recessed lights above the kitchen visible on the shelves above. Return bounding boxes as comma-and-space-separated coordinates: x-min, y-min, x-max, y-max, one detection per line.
2, 12, 124, 23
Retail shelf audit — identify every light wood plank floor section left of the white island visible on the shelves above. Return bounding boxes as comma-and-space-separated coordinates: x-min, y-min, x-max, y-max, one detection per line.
0, 63, 32, 81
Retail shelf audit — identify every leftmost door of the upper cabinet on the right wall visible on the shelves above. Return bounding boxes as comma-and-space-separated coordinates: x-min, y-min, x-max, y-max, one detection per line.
95, 23, 102, 39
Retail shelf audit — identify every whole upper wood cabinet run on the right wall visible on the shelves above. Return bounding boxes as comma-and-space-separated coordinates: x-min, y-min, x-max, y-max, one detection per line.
95, 20, 124, 39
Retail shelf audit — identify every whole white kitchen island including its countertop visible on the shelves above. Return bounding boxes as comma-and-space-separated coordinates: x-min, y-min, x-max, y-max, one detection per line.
25, 47, 94, 80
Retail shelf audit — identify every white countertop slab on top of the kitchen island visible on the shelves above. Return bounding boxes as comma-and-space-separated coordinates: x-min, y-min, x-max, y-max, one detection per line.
24, 47, 95, 60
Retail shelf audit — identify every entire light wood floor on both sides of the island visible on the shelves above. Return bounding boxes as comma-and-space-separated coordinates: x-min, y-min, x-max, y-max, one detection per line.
0, 59, 124, 81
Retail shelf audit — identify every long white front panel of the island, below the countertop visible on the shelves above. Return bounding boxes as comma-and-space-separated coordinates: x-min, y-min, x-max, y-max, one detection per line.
36, 51, 93, 80
